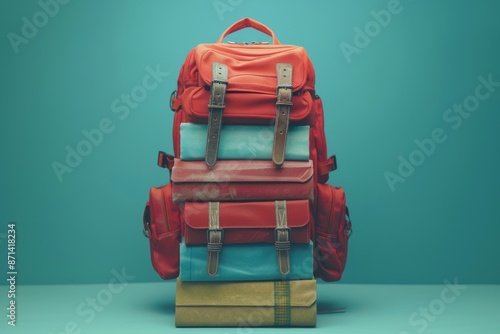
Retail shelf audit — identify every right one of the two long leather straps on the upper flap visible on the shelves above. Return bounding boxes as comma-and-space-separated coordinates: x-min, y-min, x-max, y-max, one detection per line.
273, 64, 293, 166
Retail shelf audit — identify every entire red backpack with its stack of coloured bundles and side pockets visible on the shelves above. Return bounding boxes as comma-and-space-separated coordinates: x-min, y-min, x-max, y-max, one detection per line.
143, 18, 351, 327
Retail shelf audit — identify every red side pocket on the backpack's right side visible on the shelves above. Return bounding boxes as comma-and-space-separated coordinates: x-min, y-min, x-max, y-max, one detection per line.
314, 184, 351, 282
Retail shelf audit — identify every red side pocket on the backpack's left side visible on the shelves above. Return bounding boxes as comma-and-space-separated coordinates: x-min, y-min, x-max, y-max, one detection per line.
143, 184, 181, 279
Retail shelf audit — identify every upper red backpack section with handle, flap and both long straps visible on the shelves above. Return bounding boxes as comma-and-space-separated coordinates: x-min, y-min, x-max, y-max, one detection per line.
171, 18, 336, 179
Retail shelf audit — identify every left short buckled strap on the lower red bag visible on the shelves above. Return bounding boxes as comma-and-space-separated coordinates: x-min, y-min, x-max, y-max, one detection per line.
207, 202, 224, 276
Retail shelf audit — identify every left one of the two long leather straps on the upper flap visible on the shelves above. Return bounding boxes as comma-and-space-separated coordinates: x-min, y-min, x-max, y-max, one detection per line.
205, 63, 228, 167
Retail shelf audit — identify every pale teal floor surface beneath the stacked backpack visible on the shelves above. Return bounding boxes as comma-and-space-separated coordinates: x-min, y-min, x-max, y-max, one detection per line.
0, 281, 500, 334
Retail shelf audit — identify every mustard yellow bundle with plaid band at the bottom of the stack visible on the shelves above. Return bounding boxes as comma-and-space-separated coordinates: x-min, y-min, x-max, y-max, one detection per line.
175, 279, 316, 327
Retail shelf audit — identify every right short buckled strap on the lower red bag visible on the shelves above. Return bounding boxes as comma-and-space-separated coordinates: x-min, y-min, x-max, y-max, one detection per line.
274, 201, 290, 275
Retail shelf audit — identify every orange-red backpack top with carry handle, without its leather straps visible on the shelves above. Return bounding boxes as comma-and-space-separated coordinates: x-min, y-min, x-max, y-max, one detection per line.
175, 19, 315, 125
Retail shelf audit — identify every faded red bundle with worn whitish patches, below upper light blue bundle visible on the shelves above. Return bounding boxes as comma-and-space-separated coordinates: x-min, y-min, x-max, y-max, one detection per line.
171, 159, 313, 203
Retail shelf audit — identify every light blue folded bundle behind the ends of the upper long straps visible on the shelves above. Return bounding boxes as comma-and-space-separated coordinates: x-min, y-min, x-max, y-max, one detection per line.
180, 123, 309, 161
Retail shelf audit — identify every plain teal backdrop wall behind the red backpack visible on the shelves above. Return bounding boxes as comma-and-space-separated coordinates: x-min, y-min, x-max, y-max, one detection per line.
0, 0, 500, 284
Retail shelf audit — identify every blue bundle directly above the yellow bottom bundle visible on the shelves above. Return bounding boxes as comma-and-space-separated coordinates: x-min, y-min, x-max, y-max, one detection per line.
179, 241, 313, 282
